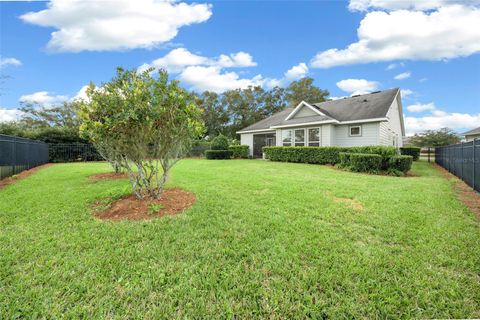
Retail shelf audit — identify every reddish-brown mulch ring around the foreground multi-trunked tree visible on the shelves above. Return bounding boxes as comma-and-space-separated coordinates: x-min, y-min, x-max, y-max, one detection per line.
93, 188, 196, 221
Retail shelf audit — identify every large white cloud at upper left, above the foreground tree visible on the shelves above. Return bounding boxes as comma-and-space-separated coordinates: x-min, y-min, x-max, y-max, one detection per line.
20, 0, 212, 52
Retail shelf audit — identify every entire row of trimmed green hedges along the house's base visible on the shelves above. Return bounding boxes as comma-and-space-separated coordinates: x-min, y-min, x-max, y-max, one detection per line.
263, 146, 412, 173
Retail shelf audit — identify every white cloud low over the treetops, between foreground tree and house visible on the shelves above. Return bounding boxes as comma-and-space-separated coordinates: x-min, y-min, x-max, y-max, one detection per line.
142, 48, 308, 93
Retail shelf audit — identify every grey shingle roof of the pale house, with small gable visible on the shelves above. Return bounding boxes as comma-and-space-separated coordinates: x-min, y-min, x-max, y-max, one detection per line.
238, 88, 400, 133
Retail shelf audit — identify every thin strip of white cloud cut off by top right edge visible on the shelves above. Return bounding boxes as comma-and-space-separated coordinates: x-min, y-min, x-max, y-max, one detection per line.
348, 0, 480, 11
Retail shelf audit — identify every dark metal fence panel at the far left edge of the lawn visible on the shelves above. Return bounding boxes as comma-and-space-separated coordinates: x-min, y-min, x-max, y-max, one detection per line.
0, 134, 48, 180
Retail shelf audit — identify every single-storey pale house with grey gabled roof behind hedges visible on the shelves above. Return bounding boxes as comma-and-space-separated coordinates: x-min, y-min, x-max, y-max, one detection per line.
237, 88, 405, 157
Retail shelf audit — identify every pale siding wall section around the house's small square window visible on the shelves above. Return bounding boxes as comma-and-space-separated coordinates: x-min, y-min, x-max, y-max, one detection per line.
333, 122, 379, 147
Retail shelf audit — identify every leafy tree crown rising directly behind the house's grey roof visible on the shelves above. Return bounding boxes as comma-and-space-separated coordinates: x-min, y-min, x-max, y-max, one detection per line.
286, 77, 330, 107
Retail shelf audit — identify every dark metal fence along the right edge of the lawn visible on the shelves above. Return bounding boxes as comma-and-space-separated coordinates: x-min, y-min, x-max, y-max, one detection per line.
435, 139, 480, 192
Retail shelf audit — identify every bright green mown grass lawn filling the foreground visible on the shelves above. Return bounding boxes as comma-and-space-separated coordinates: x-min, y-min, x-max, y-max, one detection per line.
0, 160, 480, 319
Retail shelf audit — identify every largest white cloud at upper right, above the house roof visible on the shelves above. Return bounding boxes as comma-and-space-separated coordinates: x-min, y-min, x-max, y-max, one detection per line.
311, 1, 480, 68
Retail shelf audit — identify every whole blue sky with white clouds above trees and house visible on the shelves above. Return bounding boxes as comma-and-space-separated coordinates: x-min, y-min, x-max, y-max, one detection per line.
0, 0, 480, 134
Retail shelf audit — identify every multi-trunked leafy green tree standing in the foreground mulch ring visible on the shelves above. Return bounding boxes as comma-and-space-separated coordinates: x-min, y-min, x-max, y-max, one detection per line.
79, 68, 204, 199
